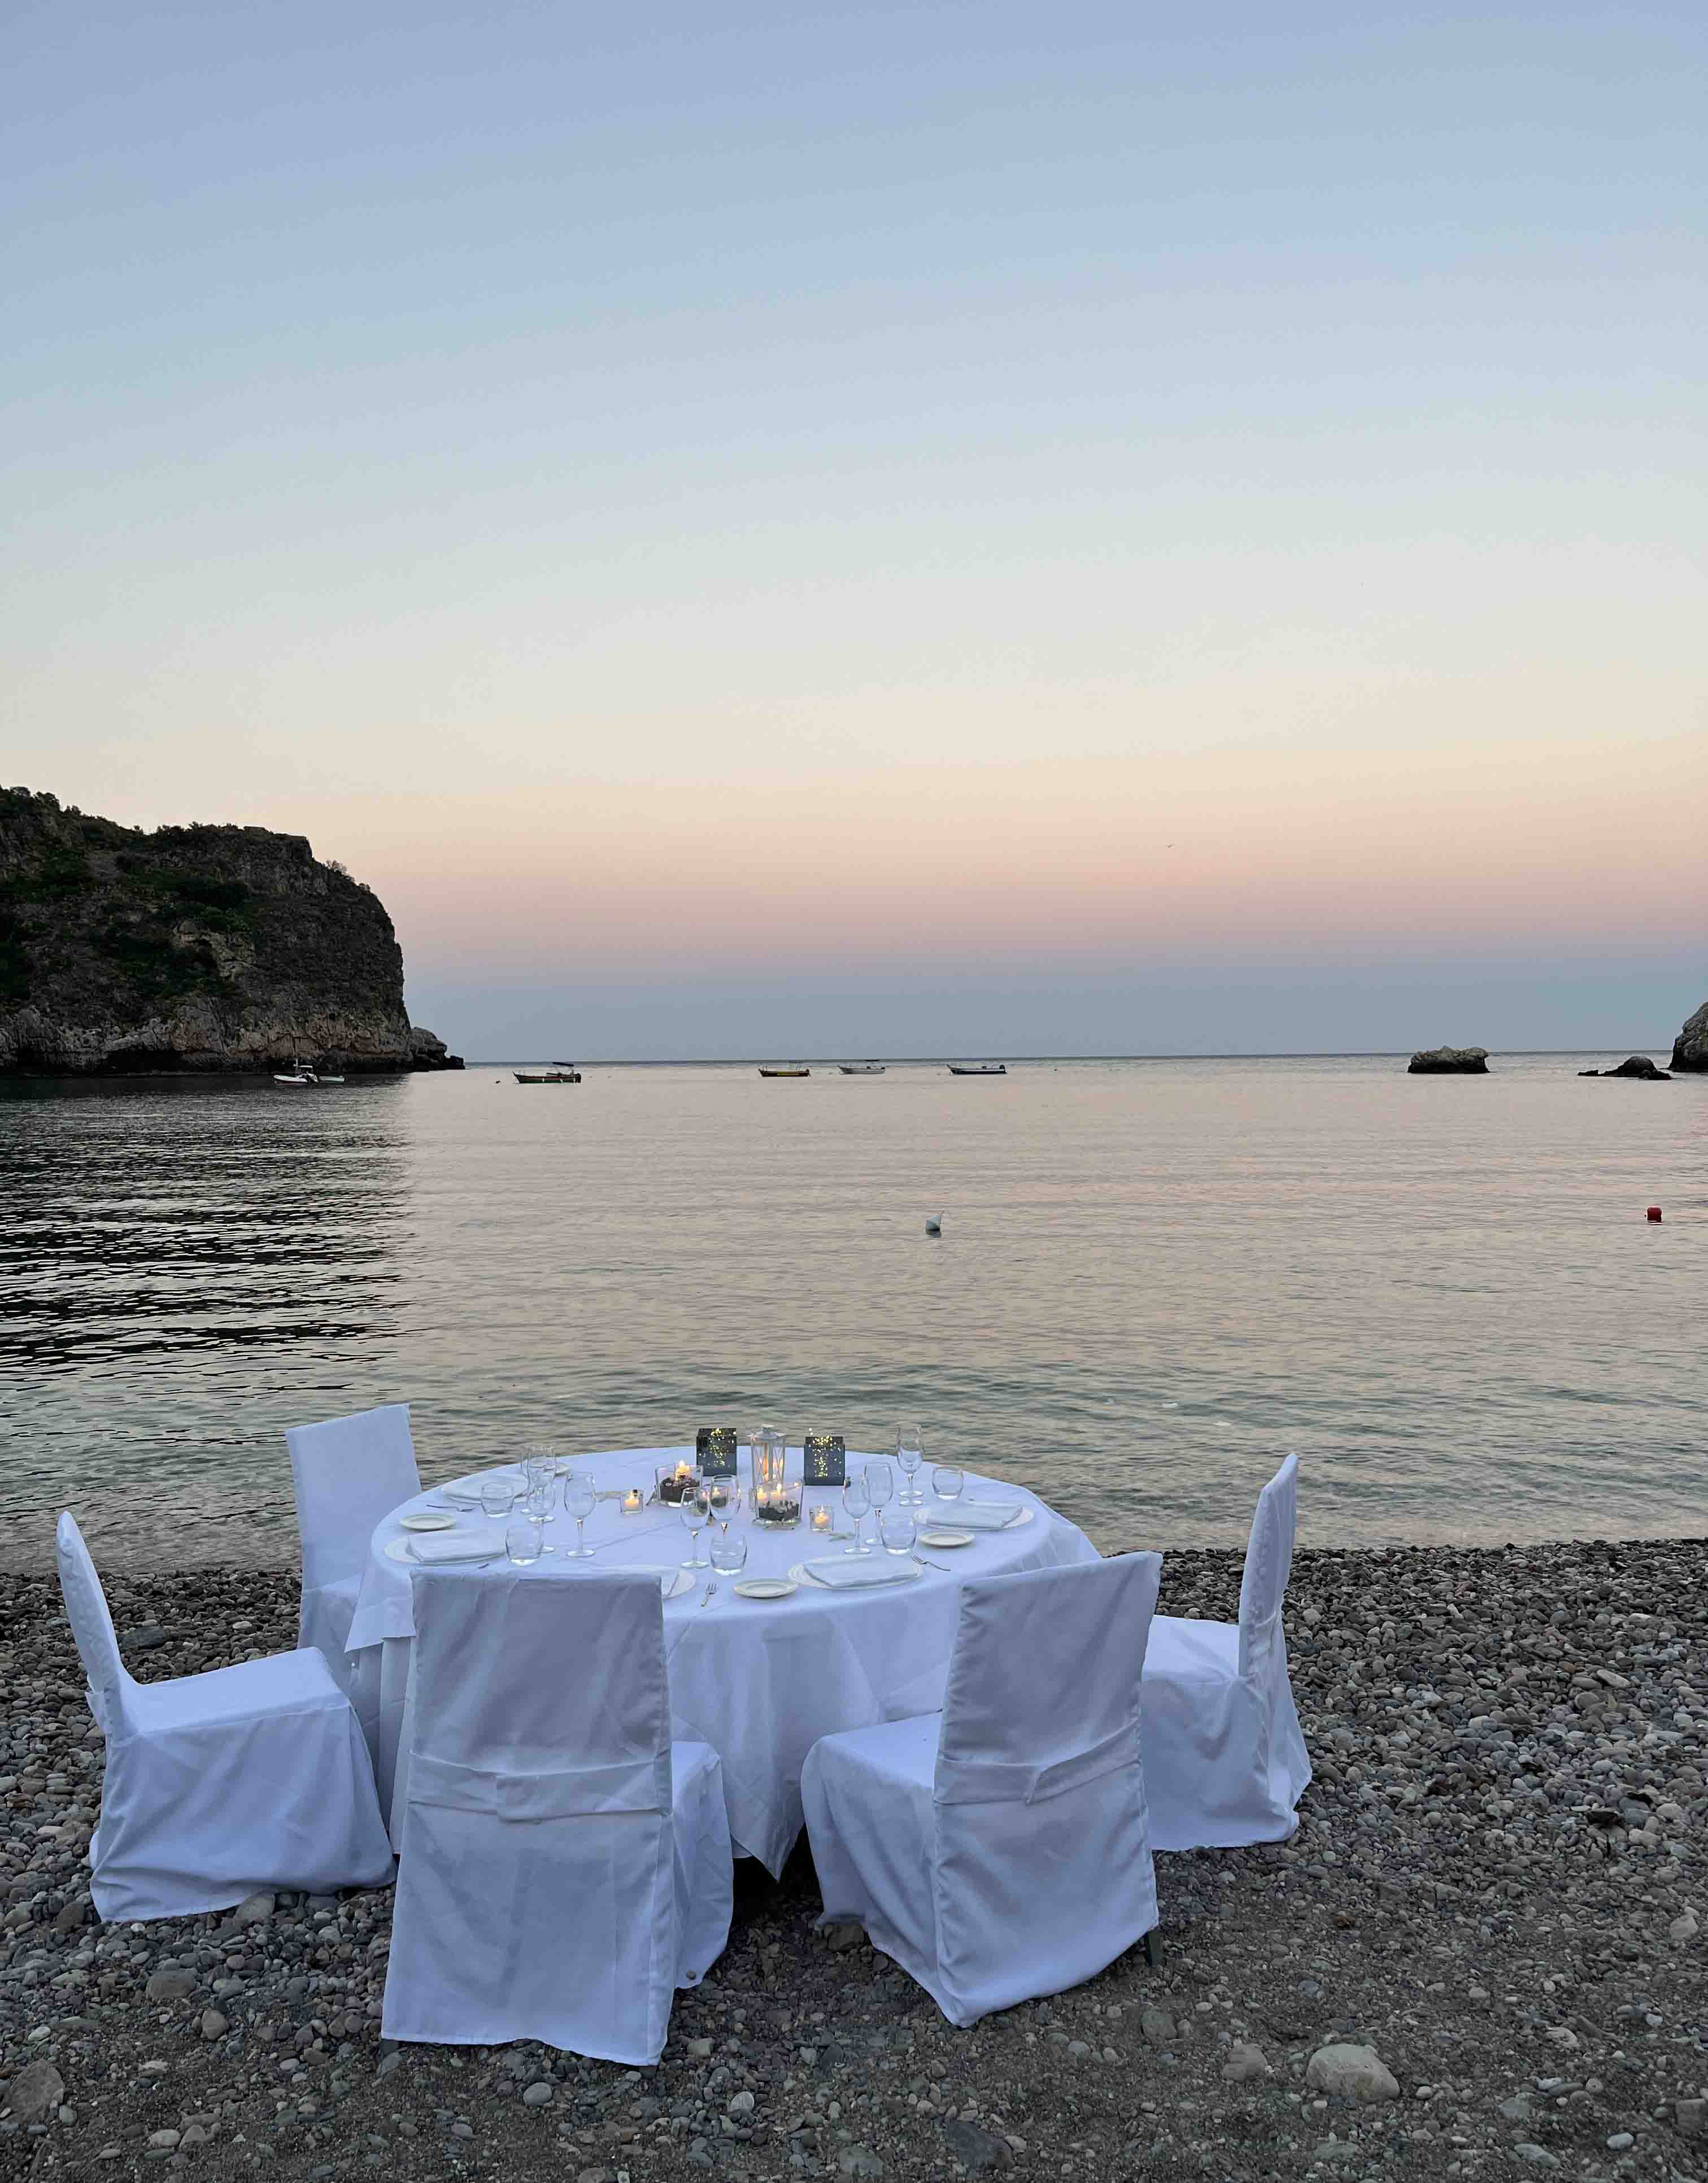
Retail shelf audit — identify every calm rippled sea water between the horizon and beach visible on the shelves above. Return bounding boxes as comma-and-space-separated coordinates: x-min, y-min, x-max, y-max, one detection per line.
0, 1055, 1708, 1567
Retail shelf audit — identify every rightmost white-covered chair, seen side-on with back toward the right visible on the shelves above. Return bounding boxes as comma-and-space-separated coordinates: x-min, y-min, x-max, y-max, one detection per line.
1144, 1456, 1310, 1849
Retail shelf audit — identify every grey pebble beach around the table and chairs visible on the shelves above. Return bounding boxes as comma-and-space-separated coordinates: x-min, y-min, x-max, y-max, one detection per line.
0, 1539, 1708, 2183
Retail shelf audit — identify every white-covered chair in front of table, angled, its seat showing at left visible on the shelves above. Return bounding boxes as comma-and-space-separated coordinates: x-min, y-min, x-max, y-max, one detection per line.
801, 1554, 1162, 2024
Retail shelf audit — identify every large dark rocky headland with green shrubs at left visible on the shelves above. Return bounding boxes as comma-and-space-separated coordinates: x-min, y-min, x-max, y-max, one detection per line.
0, 788, 463, 1076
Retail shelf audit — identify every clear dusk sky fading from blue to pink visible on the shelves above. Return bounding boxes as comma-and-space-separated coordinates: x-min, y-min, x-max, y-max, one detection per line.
0, 0, 1708, 1059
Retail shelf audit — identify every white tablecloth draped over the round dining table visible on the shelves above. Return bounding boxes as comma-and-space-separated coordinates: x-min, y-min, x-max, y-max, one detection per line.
350, 1447, 1096, 1873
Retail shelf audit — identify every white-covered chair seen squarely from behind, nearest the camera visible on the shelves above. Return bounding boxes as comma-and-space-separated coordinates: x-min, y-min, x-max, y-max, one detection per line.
382, 1570, 734, 2069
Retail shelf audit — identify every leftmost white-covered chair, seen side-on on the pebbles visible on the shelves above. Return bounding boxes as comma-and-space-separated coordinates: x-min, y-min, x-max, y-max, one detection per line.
57, 1515, 391, 1919
